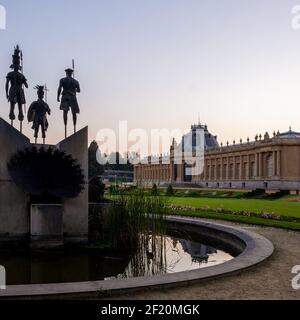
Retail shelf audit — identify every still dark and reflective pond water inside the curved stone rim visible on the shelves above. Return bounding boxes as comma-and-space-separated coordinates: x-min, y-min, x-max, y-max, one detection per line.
0, 235, 234, 285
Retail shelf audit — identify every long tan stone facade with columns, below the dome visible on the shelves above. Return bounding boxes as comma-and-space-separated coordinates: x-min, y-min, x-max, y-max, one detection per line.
134, 126, 300, 191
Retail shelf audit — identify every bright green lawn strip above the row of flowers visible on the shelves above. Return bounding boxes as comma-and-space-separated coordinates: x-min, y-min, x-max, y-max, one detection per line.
169, 197, 300, 218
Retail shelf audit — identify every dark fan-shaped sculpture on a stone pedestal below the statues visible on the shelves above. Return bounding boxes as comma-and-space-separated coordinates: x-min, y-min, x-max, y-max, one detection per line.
7, 147, 85, 198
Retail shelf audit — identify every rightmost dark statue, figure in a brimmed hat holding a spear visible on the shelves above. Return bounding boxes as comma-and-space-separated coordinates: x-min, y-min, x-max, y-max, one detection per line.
57, 69, 80, 137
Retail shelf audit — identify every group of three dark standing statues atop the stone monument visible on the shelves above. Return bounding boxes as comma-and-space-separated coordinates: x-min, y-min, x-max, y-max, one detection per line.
5, 46, 80, 144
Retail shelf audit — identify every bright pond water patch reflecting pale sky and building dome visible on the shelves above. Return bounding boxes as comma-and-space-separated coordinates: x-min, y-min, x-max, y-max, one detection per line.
106, 236, 233, 279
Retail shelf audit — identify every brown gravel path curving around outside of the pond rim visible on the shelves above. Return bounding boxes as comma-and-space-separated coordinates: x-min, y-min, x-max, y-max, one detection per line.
111, 220, 300, 300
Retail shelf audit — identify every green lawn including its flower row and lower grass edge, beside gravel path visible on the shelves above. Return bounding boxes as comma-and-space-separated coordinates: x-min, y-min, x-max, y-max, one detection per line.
108, 194, 300, 231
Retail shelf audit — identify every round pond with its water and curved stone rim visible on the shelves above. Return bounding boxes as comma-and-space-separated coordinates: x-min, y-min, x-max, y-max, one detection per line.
0, 217, 274, 299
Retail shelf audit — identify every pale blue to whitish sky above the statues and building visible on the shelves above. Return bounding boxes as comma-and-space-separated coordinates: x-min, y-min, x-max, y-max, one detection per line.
0, 0, 300, 150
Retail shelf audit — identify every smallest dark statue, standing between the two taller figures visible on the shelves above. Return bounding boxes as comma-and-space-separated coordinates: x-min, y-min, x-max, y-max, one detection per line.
27, 86, 51, 144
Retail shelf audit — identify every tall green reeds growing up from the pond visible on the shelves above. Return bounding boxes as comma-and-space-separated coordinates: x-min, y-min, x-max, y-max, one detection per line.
108, 190, 167, 252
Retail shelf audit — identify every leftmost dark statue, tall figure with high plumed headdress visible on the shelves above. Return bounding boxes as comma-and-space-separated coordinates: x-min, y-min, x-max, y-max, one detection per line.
5, 46, 28, 132
